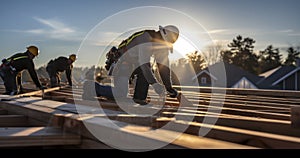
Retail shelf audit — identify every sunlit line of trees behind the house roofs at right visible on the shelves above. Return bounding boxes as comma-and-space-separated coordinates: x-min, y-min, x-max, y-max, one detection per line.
175, 35, 300, 75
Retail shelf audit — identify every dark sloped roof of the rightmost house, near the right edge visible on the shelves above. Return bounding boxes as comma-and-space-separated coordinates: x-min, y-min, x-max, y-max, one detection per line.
257, 66, 297, 88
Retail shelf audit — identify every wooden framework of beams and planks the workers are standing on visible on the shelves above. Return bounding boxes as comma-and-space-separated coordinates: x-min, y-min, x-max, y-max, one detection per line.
0, 84, 300, 150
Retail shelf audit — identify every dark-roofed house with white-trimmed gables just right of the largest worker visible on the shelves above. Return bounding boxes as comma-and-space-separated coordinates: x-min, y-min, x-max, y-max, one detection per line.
192, 62, 262, 89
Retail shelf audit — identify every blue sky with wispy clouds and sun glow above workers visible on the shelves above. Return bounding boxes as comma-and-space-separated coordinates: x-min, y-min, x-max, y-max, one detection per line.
0, 0, 300, 67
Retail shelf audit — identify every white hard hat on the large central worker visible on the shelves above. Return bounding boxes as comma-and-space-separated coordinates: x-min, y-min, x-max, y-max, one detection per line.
159, 25, 179, 43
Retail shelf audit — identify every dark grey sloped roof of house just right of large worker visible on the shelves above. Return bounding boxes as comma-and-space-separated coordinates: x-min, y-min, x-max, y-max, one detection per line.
196, 62, 261, 87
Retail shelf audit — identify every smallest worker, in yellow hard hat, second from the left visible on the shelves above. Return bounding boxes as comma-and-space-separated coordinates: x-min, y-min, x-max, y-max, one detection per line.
46, 54, 77, 87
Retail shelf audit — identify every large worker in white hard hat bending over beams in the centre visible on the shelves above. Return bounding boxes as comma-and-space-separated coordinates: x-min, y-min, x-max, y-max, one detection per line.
107, 25, 179, 105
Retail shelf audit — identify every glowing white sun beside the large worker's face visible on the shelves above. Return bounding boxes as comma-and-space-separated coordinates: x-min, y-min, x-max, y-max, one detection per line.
169, 35, 197, 60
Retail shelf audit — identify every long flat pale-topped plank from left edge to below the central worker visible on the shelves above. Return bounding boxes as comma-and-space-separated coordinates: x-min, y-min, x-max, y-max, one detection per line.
0, 98, 156, 126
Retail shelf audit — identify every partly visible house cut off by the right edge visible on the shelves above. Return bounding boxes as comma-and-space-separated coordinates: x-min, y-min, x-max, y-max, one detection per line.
257, 59, 300, 91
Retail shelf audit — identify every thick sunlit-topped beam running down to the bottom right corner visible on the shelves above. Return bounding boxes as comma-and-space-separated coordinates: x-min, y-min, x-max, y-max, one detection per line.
157, 120, 300, 149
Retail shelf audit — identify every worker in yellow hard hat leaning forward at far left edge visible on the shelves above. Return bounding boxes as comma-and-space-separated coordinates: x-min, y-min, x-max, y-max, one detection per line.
0, 46, 44, 95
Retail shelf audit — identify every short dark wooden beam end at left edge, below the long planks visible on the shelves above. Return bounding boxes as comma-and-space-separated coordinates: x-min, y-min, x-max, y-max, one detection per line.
0, 115, 29, 127
